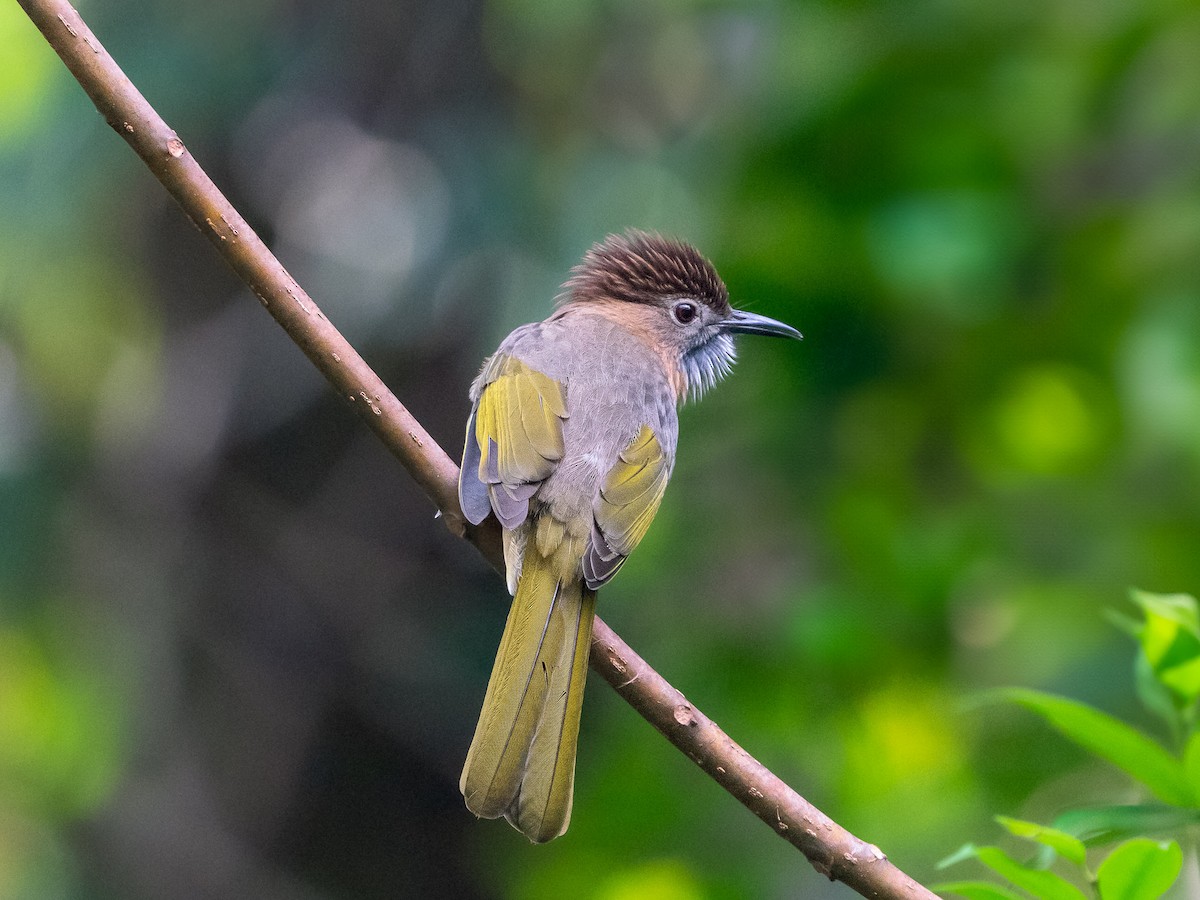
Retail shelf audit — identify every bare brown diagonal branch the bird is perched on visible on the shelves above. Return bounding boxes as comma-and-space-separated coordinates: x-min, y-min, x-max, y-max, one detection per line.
18, 0, 934, 900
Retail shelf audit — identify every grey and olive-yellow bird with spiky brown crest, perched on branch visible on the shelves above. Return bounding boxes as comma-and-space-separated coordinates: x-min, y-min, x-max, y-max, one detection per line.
458, 232, 800, 844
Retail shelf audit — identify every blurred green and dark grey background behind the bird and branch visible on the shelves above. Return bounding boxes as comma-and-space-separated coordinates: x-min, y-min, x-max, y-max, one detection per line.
0, 0, 1200, 900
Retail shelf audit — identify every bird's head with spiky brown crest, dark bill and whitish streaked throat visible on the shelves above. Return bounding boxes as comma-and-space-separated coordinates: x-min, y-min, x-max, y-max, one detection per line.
560, 232, 800, 397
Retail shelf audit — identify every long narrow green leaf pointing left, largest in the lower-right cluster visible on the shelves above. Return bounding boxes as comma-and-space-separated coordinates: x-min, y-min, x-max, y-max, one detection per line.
998, 688, 1195, 806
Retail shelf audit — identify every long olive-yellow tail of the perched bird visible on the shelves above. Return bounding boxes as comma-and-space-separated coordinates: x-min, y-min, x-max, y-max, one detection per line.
458, 541, 595, 844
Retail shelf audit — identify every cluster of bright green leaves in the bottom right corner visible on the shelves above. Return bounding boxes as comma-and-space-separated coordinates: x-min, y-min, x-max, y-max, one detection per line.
937, 590, 1200, 900
